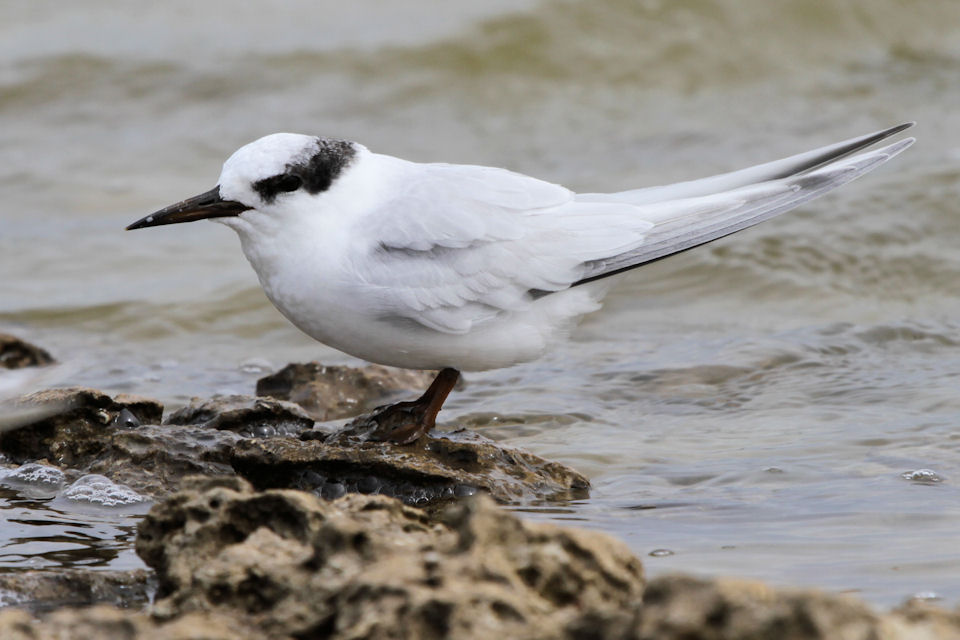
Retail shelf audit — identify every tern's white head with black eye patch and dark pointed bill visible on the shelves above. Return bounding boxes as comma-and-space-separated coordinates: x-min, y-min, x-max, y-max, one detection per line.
127, 133, 362, 230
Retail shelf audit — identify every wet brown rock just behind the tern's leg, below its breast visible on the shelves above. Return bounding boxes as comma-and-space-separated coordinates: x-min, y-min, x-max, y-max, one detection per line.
257, 362, 436, 422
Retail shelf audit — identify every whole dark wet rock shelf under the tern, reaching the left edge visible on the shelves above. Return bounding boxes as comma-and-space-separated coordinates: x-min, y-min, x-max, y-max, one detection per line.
0, 389, 589, 506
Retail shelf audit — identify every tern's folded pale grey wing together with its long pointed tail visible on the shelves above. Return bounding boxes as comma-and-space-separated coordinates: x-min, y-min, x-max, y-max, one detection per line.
357, 125, 913, 334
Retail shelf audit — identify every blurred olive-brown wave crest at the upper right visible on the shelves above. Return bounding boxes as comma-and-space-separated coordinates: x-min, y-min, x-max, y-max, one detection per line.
362, 0, 960, 88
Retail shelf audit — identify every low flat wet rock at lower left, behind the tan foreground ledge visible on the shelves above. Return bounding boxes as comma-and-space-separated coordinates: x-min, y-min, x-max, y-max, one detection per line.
0, 569, 156, 616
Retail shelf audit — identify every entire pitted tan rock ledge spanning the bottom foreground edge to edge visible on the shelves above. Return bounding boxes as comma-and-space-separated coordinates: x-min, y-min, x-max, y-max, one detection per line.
0, 477, 960, 640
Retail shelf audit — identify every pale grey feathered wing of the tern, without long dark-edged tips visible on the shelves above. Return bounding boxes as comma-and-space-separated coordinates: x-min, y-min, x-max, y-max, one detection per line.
357, 165, 653, 334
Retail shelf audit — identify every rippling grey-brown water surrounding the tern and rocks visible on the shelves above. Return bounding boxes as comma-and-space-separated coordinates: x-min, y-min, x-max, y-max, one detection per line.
0, 0, 960, 605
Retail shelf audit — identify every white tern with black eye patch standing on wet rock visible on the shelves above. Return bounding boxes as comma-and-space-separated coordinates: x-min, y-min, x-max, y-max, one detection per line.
127, 123, 914, 444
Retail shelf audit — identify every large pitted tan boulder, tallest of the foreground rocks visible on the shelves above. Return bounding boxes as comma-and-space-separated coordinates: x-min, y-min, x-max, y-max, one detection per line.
137, 481, 643, 638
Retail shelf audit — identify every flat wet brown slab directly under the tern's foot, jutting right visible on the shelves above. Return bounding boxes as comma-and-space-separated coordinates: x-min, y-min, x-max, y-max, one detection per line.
231, 430, 590, 505
